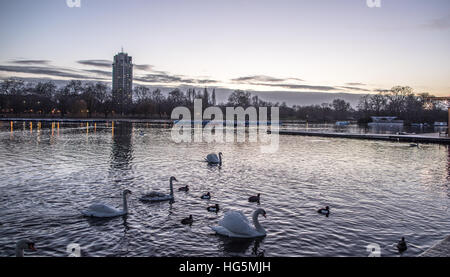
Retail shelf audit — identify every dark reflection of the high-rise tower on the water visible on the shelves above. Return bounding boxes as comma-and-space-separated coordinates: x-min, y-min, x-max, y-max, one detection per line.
111, 122, 133, 170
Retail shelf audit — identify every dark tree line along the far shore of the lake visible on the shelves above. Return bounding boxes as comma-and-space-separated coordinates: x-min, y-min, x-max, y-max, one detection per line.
0, 79, 447, 123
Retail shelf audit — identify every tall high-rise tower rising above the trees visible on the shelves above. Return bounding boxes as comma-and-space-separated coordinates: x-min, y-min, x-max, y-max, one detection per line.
112, 50, 133, 113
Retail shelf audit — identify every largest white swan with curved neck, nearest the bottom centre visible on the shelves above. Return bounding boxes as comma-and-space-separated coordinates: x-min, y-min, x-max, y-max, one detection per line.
211, 209, 266, 238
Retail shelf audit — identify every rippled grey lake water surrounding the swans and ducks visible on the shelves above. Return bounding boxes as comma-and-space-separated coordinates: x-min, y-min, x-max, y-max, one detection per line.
0, 122, 450, 256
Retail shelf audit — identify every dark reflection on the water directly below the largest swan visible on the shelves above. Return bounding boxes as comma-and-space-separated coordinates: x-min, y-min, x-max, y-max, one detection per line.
218, 236, 265, 257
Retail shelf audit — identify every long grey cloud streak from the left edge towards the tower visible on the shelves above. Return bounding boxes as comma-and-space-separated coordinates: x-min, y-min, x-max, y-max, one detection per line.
0, 65, 101, 80
